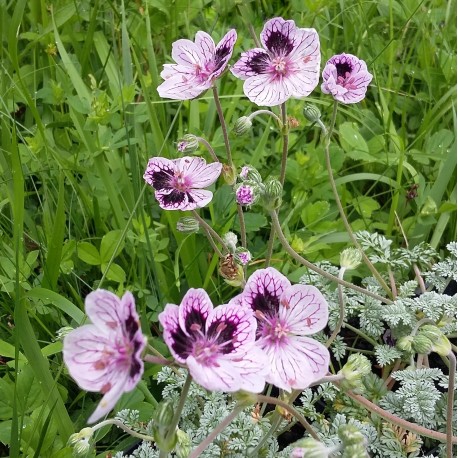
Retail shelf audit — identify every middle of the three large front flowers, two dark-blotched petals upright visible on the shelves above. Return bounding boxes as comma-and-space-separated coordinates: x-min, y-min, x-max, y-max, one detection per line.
159, 289, 267, 393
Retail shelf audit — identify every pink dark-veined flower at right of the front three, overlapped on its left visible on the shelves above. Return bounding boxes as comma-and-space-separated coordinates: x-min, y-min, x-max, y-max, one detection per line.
229, 267, 329, 391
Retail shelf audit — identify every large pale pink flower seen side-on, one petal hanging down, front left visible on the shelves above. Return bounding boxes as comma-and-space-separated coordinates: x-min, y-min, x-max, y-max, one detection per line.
63, 289, 146, 423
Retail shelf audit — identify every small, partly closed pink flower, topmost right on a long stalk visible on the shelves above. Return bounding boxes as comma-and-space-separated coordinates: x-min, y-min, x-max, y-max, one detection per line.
321, 54, 372, 104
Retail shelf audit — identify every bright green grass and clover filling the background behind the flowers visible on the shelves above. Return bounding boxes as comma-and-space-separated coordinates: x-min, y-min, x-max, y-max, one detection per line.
0, 0, 457, 458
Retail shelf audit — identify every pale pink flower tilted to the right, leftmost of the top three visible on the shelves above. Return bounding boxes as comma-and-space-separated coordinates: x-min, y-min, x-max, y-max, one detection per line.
157, 30, 237, 100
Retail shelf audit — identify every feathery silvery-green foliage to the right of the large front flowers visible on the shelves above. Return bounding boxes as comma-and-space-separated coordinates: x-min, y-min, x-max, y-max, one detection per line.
298, 238, 457, 458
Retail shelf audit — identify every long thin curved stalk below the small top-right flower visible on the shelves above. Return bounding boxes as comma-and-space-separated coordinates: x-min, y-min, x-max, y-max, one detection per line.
319, 100, 392, 297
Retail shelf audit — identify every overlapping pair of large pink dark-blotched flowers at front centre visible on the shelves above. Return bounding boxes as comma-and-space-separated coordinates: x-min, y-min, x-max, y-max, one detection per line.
159, 268, 329, 392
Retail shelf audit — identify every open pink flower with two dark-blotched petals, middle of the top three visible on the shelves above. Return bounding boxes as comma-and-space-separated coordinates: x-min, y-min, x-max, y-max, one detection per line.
231, 17, 321, 106
